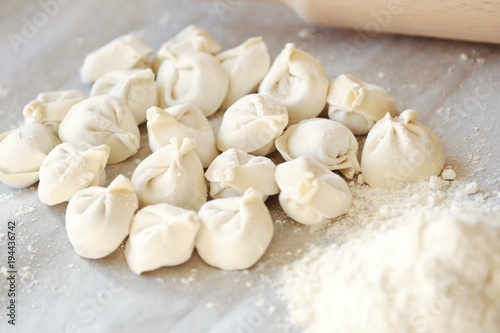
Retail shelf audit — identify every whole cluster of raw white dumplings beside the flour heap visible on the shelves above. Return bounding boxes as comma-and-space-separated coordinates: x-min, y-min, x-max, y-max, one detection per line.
0, 25, 445, 274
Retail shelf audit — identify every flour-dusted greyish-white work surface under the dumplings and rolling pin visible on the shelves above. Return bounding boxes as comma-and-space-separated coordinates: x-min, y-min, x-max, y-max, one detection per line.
0, 0, 500, 333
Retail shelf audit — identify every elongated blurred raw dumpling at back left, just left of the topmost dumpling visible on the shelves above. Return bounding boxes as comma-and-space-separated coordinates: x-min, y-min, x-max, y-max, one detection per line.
80, 34, 153, 83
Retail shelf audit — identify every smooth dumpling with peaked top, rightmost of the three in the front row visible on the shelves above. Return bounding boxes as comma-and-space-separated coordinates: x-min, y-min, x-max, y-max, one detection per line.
196, 188, 274, 270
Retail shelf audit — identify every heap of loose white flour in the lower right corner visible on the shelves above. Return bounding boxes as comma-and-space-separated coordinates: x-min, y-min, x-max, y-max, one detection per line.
282, 179, 500, 333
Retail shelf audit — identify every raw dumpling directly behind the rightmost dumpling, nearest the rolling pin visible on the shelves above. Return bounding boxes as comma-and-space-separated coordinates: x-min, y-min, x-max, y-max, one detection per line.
326, 74, 396, 135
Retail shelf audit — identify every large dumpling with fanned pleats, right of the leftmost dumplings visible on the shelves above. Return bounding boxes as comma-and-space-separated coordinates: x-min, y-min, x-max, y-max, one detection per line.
59, 95, 141, 164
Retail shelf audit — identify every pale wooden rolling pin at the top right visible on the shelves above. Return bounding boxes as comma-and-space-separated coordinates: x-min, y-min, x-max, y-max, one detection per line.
281, 0, 500, 43
